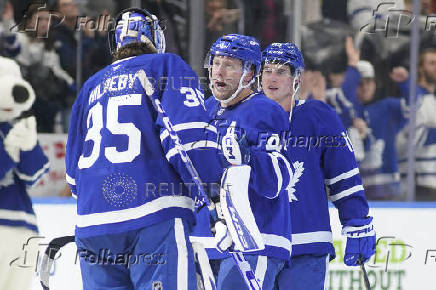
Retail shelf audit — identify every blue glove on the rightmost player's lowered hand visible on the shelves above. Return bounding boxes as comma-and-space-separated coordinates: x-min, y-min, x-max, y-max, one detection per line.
342, 217, 376, 266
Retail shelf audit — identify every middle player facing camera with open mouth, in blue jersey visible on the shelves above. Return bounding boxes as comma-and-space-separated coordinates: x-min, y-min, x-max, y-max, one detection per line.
200, 34, 291, 289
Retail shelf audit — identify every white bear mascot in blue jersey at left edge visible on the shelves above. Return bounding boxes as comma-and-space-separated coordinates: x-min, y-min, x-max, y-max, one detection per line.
0, 57, 48, 290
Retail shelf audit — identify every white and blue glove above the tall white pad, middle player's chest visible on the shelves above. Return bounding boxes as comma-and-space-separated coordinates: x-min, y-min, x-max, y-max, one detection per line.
221, 127, 250, 167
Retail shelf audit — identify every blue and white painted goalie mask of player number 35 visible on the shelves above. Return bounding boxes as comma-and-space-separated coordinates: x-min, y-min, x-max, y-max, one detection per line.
108, 8, 165, 53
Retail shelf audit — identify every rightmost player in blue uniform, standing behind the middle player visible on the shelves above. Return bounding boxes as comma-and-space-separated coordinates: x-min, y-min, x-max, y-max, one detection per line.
262, 43, 376, 290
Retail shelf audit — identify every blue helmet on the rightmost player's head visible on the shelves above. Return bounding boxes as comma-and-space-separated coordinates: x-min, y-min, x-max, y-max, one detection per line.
262, 43, 304, 76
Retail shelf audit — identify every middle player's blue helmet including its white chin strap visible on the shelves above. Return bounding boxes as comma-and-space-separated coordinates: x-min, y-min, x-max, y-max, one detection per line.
207, 34, 261, 103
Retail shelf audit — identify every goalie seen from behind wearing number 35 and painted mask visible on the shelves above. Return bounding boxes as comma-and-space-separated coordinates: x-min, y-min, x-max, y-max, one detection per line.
66, 8, 222, 289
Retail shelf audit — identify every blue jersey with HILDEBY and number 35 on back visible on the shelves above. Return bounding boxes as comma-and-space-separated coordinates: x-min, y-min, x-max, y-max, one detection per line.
66, 54, 222, 237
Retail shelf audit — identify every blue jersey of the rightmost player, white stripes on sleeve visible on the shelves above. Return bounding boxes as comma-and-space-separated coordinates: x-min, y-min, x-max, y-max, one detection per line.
285, 100, 368, 259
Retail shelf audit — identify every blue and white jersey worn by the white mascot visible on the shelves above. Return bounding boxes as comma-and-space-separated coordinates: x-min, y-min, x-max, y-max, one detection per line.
0, 122, 49, 231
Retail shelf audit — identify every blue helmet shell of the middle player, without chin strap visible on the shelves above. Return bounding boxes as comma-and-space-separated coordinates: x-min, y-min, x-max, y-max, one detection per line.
209, 34, 261, 76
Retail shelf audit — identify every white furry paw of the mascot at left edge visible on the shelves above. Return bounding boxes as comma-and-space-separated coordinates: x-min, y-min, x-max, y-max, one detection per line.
4, 116, 38, 163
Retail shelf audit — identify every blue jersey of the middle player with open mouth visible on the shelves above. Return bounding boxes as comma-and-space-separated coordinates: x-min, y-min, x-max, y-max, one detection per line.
191, 93, 291, 260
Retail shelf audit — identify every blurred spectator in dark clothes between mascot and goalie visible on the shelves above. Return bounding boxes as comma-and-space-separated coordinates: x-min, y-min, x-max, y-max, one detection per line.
12, 4, 74, 133
